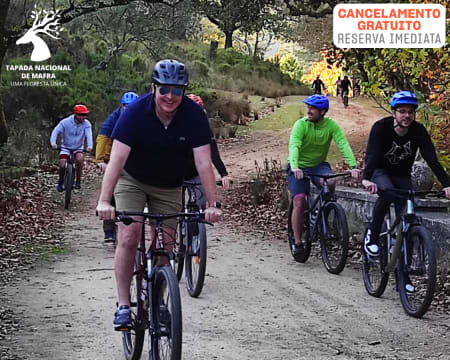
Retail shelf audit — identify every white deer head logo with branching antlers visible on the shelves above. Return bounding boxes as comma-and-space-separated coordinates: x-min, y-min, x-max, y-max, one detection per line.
16, 5, 61, 61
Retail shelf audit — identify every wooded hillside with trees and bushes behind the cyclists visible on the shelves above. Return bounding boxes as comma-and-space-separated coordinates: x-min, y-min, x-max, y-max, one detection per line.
0, 0, 450, 172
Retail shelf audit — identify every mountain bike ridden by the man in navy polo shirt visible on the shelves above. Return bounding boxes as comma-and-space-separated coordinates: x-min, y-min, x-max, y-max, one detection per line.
116, 211, 203, 360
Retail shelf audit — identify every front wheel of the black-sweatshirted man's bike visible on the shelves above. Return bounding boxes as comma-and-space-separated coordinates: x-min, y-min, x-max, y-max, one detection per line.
397, 225, 436, 318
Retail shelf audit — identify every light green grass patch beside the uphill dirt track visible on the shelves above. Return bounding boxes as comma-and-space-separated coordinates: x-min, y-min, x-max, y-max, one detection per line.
249, 104, 304, 130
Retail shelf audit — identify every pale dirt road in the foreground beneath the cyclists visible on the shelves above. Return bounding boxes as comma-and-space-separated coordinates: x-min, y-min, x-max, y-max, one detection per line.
1, 96, 450, 360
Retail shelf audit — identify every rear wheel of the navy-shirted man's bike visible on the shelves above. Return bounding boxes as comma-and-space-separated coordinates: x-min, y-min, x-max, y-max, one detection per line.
122, 249, 148, 360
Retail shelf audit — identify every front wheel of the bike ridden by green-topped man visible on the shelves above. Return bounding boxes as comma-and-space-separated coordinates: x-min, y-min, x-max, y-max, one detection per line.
320, 202, 348, 274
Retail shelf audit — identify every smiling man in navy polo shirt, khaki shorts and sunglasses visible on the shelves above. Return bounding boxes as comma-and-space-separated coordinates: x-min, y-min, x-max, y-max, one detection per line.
97, 60, 222, 330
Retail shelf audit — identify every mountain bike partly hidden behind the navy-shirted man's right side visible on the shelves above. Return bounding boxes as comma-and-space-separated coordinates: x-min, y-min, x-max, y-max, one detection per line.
175, 181, 208, 297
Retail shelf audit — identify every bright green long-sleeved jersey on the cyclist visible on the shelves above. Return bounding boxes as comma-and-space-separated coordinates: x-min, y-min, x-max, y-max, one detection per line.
288, 117, 358, 169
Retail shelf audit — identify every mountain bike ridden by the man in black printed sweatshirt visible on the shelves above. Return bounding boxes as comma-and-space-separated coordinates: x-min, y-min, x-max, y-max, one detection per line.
362, 189, 444, 318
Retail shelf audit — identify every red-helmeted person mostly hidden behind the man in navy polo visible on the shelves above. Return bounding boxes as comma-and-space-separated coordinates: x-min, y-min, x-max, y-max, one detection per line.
184, 94, 231, 202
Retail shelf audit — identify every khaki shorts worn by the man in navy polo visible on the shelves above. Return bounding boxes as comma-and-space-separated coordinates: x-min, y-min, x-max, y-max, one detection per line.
114, 171, 181, 229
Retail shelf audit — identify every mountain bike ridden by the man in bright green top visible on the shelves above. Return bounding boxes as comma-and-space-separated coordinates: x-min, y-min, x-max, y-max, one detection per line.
288, 173, 350, 274
